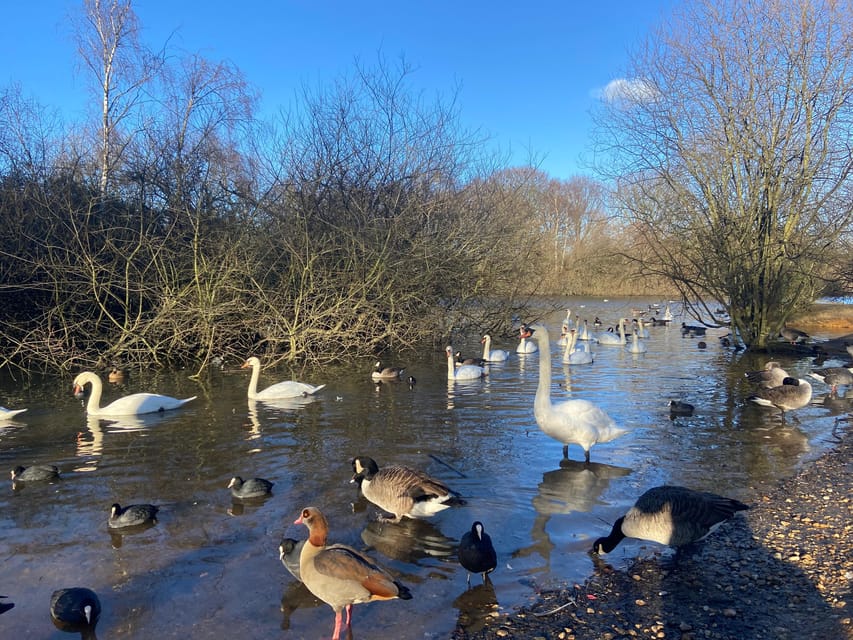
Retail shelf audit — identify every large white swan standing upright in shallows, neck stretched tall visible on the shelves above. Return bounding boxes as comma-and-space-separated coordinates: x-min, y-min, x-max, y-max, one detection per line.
530, 325, 628, 462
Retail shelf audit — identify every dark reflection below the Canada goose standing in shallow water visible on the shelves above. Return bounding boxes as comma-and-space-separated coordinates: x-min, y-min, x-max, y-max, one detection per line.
361, 518, 456, 564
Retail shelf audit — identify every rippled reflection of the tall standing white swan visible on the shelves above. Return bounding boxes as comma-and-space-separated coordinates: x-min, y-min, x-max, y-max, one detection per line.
513, 459, 631, 565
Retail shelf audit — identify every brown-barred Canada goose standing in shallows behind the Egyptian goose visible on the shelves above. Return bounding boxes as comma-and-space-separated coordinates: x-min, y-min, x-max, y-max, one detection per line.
351, 456, 459, 522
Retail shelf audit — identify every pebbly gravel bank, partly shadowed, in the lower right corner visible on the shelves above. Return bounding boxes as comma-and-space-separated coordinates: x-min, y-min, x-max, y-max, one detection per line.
453, 422, 853, 640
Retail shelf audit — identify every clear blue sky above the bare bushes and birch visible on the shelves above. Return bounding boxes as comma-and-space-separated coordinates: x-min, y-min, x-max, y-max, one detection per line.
0, 0, 677, 179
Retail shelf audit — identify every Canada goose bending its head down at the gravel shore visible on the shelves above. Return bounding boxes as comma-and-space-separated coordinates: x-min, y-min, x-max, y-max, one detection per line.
592, 485, 749, 554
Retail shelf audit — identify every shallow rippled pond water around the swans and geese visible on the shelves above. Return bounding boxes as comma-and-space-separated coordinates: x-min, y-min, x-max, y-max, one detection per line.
0, 299, 850, 640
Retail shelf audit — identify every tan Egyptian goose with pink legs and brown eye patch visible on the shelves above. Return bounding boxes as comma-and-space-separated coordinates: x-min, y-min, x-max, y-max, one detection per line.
294, 507, 412, 640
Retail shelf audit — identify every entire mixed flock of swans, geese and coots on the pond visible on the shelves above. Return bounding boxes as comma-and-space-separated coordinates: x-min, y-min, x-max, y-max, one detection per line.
0, 312, 853, 639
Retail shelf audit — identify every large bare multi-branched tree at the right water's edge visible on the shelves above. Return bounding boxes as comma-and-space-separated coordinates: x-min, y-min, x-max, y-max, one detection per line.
596, 0, 853, 348
